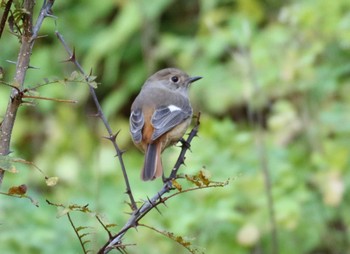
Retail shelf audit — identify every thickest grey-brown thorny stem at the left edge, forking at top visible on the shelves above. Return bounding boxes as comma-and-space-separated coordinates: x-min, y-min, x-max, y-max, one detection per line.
0, 0, 54, 186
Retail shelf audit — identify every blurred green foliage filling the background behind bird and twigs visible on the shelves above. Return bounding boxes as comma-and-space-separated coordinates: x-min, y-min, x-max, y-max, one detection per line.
0, 0, 350, 254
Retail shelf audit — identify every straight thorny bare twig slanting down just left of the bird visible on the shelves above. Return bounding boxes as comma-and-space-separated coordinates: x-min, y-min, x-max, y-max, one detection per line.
56, 31, 137, 211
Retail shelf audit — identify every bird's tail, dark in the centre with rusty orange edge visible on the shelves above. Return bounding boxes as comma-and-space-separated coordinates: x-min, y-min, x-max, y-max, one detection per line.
141, 142, 163, 181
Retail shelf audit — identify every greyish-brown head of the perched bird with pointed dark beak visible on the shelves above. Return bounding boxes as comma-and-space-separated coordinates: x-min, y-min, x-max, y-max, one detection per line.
144, 68, 202, 93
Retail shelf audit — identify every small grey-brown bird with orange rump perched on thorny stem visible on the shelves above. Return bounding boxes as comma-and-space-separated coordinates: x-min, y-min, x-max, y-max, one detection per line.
129, 68, 202, 181
